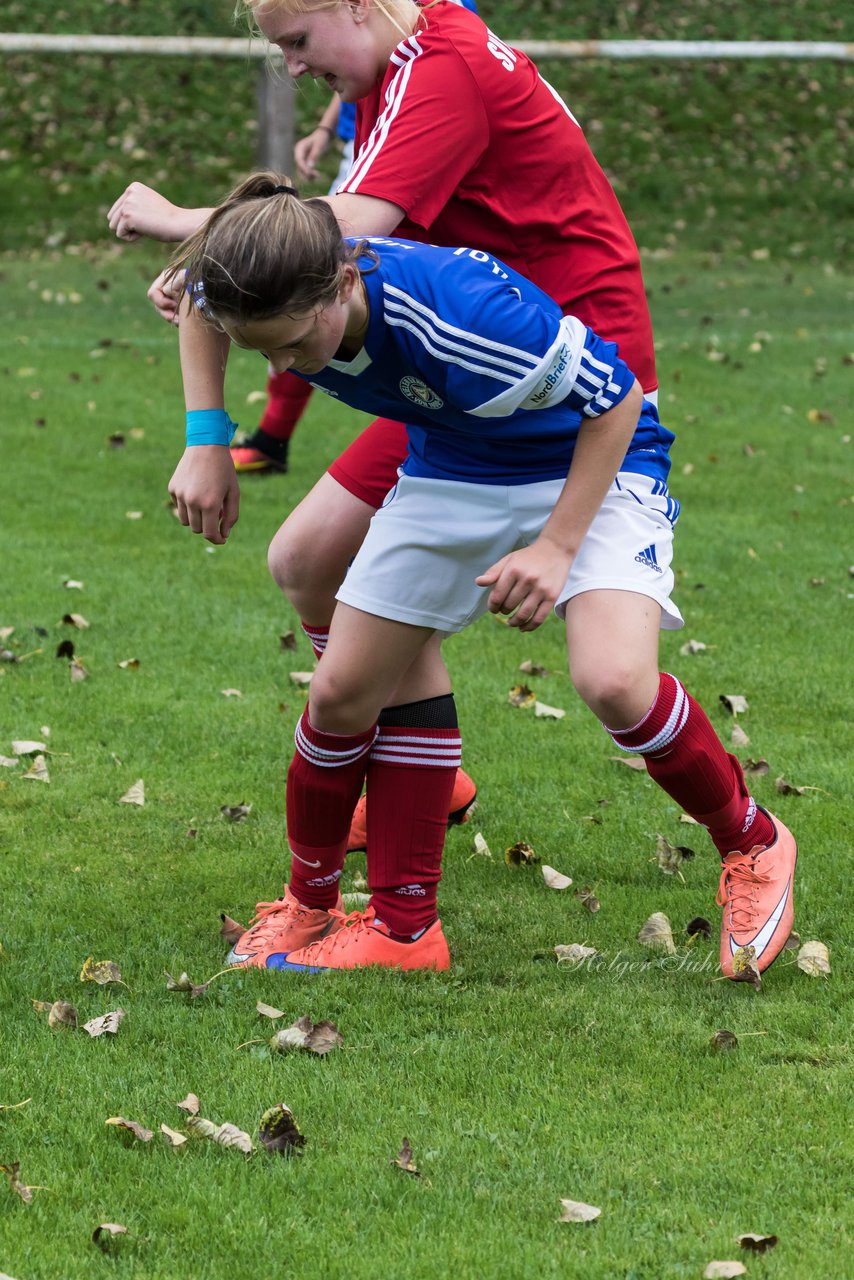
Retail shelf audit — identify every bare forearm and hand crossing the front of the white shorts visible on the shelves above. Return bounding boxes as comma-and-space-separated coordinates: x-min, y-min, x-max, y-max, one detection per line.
476, 380, 643, 631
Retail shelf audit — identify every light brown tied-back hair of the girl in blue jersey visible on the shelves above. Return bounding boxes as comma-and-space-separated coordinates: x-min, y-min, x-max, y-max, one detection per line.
168, 172, 364, 326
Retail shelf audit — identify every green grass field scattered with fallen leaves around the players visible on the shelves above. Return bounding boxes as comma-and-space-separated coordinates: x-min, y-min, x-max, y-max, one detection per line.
0, 0, 854, 1280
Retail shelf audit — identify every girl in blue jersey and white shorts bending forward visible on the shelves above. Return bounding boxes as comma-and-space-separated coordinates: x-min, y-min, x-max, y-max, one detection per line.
170, 174, 795, 975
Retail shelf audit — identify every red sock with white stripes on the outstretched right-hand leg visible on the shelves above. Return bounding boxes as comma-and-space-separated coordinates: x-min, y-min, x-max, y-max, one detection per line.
608, 672, 775, 854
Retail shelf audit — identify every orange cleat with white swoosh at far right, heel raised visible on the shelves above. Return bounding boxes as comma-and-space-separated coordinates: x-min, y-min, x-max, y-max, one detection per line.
717, 814, 798, 978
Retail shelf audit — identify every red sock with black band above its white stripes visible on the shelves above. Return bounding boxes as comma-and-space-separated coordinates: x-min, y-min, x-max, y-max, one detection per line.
366, 695, 461, 937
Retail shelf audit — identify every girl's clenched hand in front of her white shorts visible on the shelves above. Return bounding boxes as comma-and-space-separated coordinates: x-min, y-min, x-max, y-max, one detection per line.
475, 538, 572, 631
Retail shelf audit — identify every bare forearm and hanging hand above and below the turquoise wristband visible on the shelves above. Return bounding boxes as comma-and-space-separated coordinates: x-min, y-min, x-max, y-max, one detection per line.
169, 293, 239, 545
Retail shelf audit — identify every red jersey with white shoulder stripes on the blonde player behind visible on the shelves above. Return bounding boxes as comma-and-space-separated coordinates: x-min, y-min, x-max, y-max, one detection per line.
339, 0, 657, 390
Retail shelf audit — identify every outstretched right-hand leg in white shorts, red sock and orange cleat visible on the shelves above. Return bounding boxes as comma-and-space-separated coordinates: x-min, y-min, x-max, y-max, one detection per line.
566, 484, 796, 977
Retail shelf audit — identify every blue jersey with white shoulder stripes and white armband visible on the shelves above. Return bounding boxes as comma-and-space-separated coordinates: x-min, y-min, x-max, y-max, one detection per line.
300, 237, 673, 484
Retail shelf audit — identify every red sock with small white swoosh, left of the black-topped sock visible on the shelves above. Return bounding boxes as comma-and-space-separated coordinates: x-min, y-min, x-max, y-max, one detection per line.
287, 708, 376, 910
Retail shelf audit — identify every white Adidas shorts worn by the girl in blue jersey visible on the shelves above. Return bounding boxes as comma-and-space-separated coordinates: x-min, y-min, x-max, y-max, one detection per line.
337, 471, 684, 632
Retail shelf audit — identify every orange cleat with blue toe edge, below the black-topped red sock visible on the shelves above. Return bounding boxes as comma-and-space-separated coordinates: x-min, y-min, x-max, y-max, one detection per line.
270, 906, 451, 973
